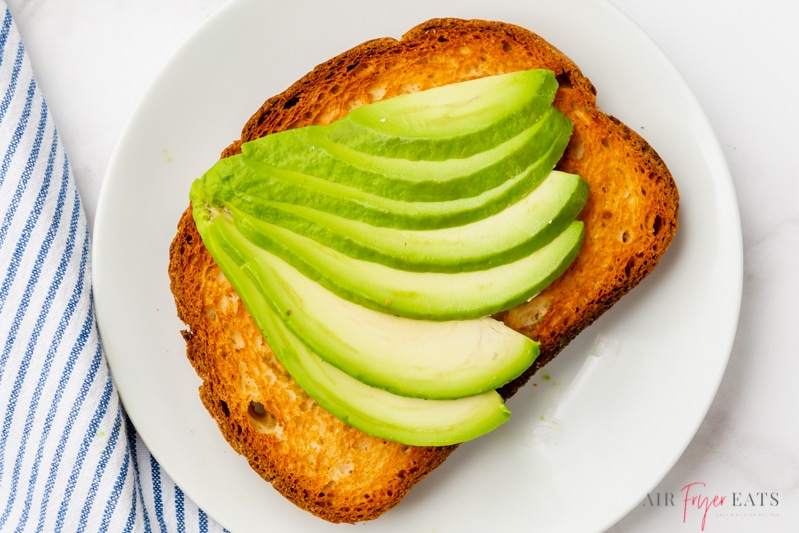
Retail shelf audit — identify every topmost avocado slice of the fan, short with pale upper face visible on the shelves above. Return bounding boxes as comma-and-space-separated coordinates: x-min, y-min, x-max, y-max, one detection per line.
325, 69, 558, 161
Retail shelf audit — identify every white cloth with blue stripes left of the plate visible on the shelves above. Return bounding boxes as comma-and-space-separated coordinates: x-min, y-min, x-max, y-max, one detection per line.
0, 2, 228, 533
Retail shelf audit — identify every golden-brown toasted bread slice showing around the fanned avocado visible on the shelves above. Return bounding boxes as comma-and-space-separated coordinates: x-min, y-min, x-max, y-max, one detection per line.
169, 19, 679, 522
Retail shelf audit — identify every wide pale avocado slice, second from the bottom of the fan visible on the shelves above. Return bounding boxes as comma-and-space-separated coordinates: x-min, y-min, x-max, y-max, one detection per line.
206, 214, 538, 399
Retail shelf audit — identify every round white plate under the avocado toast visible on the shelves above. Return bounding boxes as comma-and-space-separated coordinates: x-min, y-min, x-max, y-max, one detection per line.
93, 0, 742, 533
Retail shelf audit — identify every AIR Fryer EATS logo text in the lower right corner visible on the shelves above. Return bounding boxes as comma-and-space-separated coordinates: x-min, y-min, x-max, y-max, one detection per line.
641, 481, 780, 531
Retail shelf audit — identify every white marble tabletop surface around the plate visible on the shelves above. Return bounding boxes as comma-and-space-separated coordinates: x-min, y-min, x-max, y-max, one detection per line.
8, 0, 799, 533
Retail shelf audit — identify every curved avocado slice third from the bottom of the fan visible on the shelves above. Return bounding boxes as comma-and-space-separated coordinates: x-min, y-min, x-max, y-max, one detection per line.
195, 207, 583, 320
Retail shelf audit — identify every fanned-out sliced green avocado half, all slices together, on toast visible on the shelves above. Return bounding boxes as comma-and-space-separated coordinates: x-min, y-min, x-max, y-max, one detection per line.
190, 70, 588, 445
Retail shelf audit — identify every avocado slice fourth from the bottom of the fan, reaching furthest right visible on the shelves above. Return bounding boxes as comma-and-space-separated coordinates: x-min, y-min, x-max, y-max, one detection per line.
229, 171, 588, 272
